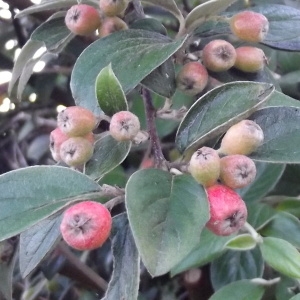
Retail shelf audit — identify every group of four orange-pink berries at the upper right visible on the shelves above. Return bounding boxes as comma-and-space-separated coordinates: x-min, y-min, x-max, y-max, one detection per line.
176, 11, 269, 96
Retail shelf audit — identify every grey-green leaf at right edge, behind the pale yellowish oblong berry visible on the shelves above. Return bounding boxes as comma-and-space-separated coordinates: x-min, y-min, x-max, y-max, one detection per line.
250, 107, 300, 163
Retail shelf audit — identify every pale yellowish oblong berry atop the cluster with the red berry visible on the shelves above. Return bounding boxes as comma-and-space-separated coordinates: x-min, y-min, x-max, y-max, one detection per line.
219, 120, 264, 155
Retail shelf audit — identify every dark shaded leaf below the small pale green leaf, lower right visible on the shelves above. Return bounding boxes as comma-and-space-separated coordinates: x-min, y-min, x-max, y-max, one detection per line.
210, 248, 264, 290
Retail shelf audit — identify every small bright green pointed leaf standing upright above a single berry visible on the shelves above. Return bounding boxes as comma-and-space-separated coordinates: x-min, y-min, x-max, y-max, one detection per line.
96, 64, 128, 116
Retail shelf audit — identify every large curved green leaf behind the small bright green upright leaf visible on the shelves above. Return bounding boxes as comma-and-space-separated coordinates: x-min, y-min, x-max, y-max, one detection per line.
71, 29, 184, 111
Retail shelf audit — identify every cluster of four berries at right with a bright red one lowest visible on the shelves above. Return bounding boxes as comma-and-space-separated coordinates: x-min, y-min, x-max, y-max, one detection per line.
189, 120, 264, 236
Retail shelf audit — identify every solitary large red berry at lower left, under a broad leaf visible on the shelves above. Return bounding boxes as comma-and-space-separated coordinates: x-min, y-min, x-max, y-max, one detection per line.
60, 201, 112, 251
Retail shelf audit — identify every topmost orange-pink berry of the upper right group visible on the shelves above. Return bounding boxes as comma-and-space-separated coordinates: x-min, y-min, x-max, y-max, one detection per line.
230, 11, 269, 43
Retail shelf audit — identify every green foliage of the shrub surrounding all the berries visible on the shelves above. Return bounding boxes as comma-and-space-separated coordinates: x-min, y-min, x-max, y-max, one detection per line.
0, 0, 300, 300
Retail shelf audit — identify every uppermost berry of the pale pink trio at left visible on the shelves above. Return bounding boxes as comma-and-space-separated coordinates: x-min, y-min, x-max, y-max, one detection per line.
57, 106, 97, 137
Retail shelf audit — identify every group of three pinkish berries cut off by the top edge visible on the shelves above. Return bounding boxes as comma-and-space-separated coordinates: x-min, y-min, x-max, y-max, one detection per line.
65, 0, 128, 37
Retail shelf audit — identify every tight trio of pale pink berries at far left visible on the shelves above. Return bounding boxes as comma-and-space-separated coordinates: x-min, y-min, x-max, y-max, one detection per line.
50, 106, 97, 167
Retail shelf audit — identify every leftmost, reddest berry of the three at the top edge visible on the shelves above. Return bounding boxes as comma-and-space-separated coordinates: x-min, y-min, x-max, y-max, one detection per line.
65, 4, 101, 35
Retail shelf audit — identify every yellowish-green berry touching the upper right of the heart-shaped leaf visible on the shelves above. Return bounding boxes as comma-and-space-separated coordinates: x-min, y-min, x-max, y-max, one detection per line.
189, 147, 220, 187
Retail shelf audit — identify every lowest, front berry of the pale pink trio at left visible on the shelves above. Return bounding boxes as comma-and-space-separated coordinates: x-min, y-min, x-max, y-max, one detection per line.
59, 137, 94, 167
